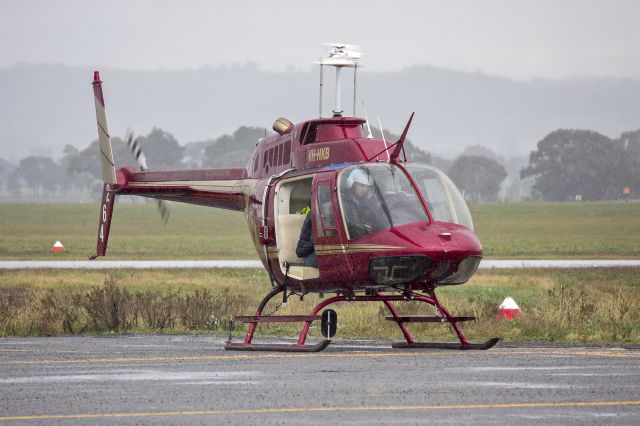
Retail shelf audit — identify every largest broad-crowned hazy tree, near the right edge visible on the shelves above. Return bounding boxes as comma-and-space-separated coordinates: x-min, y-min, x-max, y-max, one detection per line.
520, 130, 629, 201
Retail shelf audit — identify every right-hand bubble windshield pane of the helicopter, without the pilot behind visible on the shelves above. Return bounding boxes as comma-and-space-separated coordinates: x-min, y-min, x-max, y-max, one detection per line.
405, 164, 473, 229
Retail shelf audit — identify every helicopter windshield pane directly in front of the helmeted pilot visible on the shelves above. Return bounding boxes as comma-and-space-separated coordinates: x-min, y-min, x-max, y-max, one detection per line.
339, 164, 429, 239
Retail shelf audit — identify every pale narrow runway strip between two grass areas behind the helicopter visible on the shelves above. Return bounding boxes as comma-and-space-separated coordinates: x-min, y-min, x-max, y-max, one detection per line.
0, 259, 640, 269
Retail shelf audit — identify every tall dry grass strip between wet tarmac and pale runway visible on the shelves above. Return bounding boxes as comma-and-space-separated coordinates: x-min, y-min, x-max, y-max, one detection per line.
0, 268, 640, 343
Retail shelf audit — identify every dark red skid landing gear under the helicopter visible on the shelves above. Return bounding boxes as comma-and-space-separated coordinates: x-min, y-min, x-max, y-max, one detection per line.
225, 286, 499, 352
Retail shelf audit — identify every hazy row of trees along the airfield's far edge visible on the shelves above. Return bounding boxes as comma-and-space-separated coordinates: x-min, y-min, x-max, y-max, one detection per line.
0, 126, 640, 202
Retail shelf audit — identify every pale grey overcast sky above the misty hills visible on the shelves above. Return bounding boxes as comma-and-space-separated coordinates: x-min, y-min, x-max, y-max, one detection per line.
0, 0, 640, 79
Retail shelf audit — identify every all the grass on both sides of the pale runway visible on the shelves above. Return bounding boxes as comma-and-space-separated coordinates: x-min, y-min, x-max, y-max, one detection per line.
0, 202, 640, 343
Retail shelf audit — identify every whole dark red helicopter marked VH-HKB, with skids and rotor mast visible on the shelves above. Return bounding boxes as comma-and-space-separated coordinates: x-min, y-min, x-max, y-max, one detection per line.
92, 44, 499, 352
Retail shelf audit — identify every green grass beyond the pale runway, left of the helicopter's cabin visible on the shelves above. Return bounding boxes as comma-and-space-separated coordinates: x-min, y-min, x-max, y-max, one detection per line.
0, 203, 256, 260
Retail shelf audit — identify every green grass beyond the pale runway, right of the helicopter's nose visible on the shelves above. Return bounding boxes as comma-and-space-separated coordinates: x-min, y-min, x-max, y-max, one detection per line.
471, 202, 640, 259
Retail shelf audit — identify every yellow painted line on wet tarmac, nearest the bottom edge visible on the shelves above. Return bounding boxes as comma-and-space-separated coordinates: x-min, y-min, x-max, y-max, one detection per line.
0, 401, 640, 421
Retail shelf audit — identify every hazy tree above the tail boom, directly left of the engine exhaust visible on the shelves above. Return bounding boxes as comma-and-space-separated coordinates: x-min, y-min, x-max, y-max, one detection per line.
202, 126, 265, 167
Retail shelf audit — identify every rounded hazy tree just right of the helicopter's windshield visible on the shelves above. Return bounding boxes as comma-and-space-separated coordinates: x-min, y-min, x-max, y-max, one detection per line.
449, 155, 507, 202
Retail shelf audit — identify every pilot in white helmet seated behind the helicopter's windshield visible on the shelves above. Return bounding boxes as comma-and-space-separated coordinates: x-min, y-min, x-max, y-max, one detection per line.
342, 169, 382, 238
